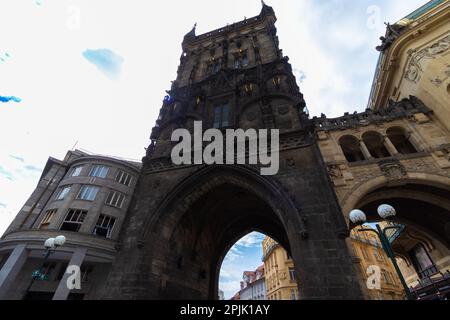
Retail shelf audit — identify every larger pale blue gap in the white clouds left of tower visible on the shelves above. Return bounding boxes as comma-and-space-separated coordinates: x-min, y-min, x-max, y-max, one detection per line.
83, 49, 124, 80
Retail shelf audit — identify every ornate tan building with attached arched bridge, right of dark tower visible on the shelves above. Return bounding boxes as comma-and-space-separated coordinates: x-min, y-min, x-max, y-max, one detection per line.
315, 0, 450, 298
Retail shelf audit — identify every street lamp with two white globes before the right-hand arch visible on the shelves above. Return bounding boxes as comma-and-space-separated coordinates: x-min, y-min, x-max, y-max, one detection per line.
349, 204, 414, 300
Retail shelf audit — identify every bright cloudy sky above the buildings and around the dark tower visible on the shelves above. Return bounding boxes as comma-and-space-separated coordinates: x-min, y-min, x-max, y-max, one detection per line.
0, 0, 427, 298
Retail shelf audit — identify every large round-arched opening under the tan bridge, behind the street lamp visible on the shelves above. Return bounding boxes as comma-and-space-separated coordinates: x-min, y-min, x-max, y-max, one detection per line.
352, 183, 450, 299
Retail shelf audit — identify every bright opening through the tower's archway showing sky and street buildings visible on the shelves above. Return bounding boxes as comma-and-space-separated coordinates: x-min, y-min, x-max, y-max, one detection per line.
218, 232, 299, 300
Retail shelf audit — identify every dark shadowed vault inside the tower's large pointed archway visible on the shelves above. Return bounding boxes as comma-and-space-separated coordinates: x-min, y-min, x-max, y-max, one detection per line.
166, 178, 302, 299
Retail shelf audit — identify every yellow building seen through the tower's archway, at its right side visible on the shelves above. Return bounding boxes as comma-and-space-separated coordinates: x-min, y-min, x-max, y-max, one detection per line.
262, 237, 298, 300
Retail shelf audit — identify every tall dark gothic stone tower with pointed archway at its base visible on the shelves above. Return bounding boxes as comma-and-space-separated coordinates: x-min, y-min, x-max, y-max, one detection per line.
104, 4, 361, 299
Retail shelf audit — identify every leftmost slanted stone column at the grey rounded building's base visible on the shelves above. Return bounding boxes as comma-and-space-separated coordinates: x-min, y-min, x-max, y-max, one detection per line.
0, 244, 31, 300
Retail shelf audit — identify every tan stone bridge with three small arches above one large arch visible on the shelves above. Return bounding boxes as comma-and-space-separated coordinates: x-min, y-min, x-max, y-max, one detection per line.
316, 97, 450, 298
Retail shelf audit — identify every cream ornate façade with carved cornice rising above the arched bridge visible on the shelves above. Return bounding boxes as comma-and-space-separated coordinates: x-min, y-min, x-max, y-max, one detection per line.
369, 0, 450, 130
